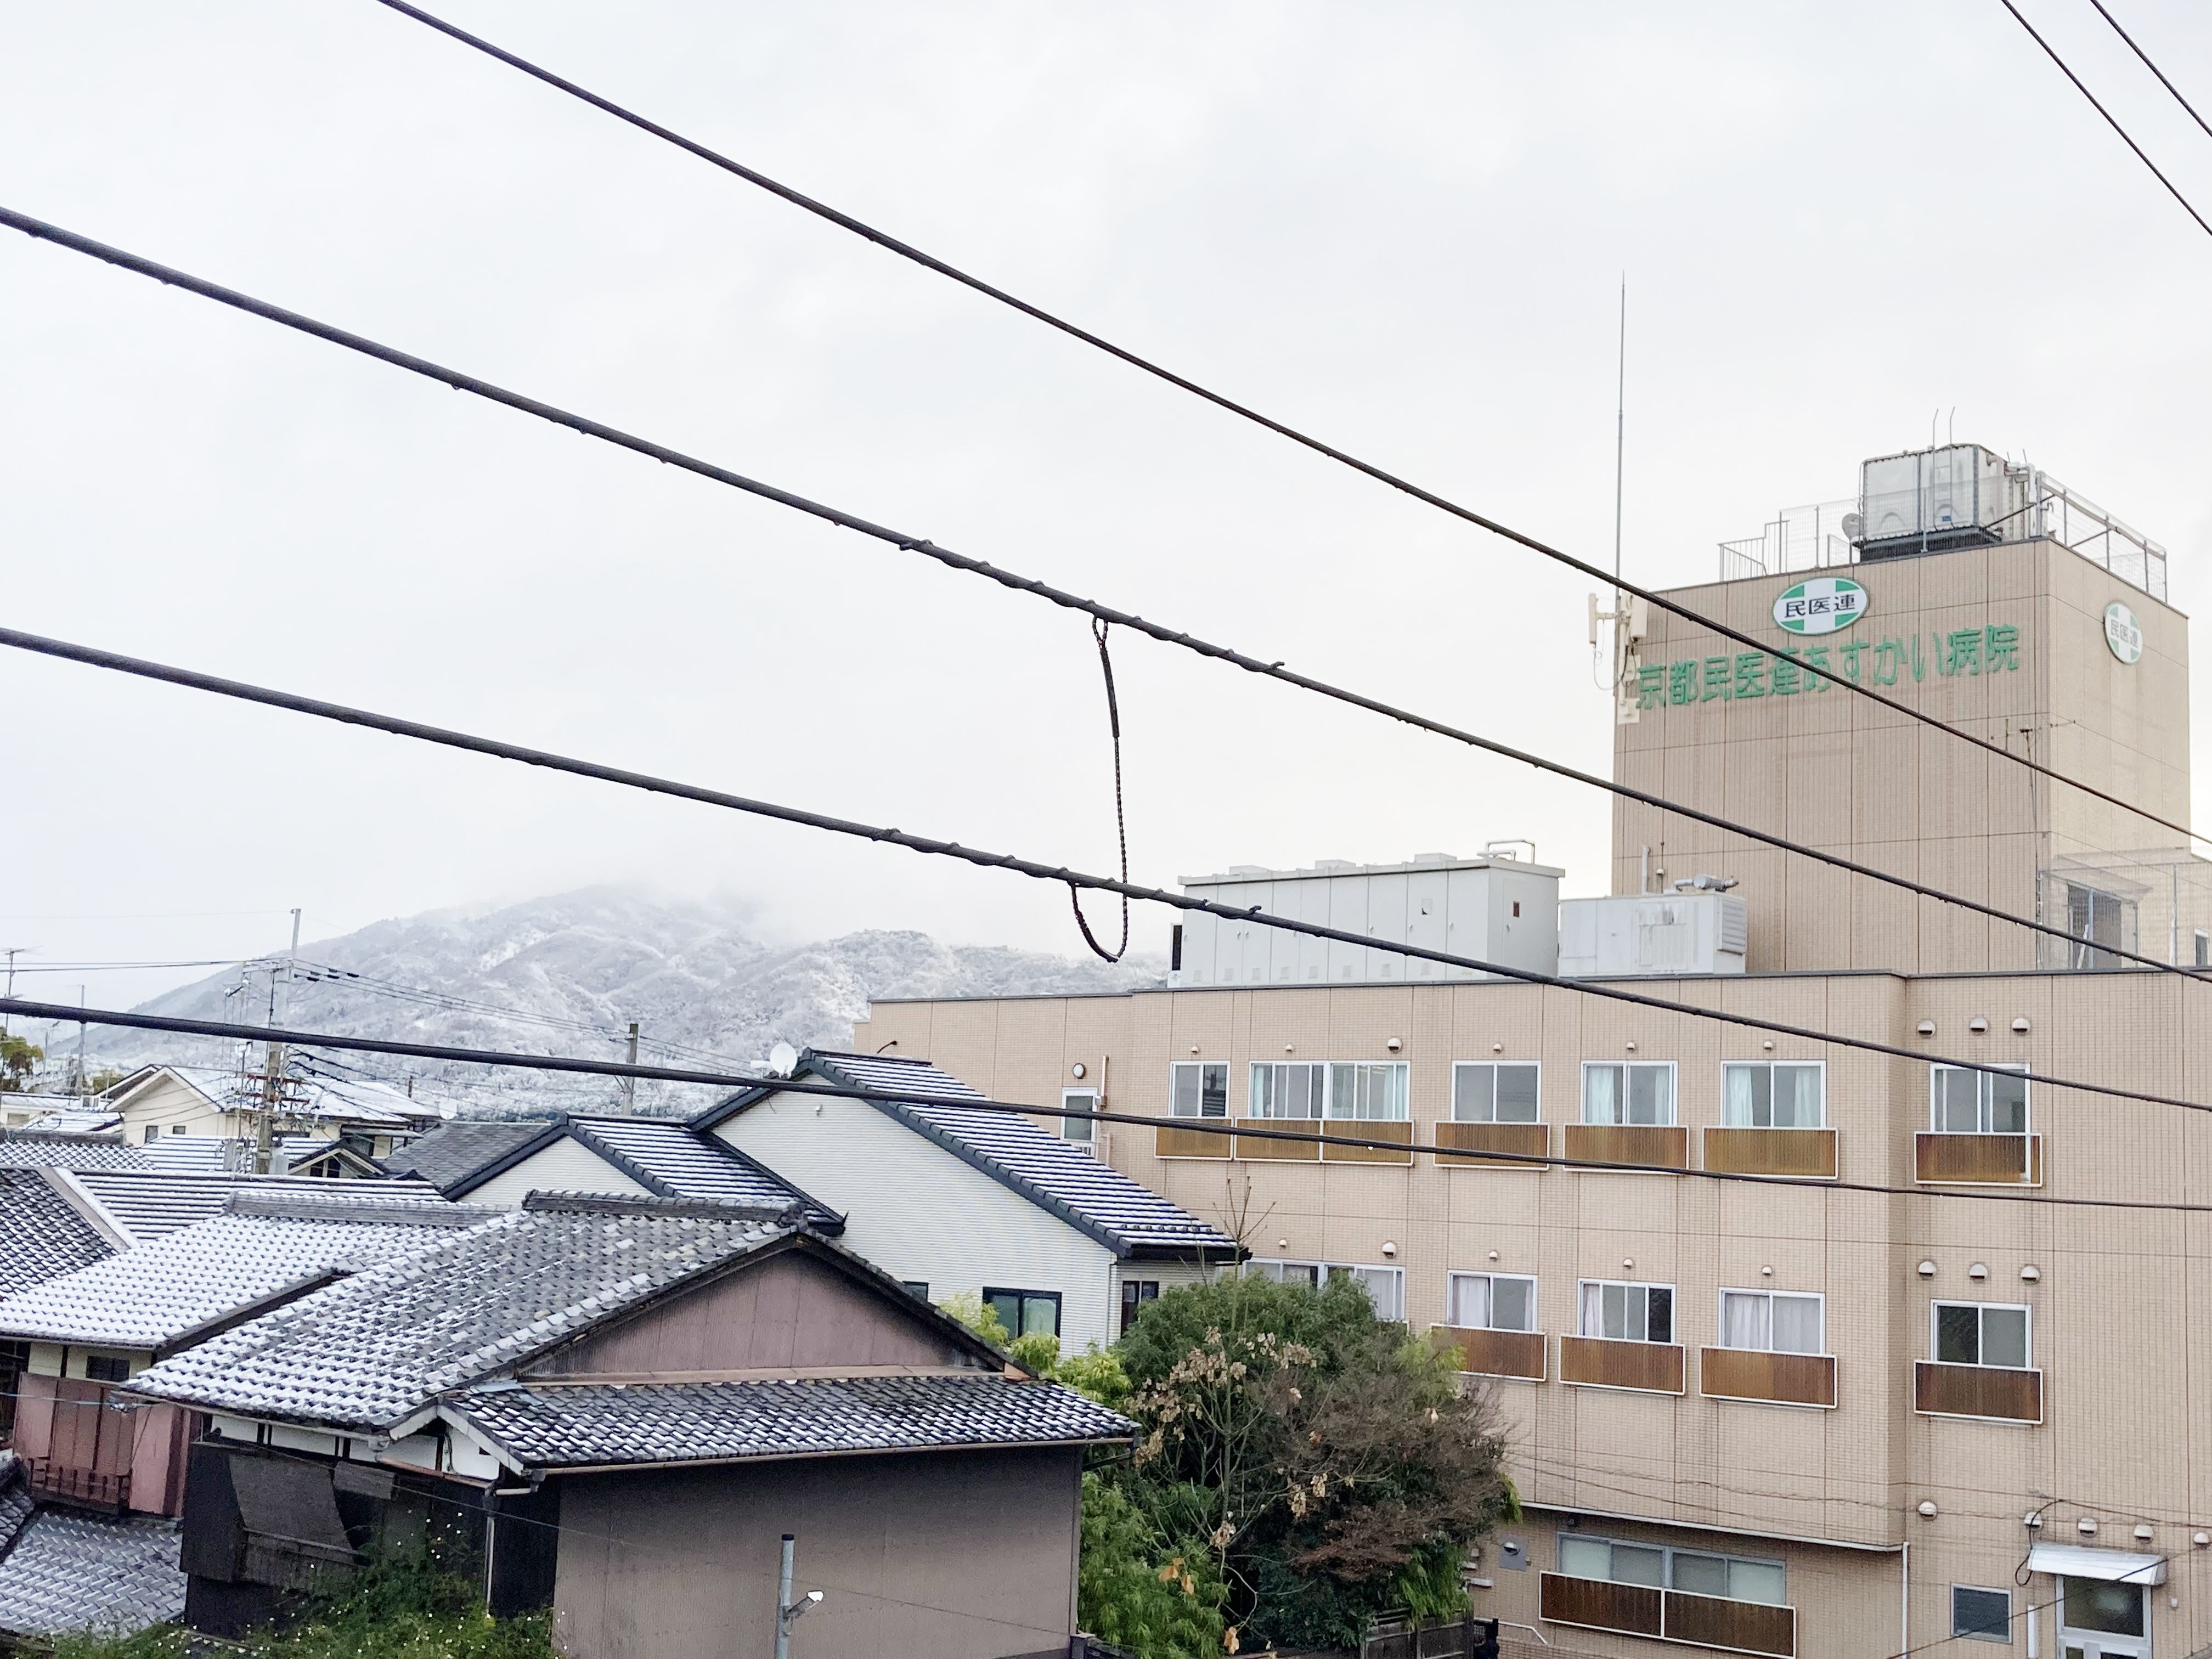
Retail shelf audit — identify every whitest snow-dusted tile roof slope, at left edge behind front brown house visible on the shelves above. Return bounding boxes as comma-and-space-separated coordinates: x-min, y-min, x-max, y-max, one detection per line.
0, 1181, 484, 1350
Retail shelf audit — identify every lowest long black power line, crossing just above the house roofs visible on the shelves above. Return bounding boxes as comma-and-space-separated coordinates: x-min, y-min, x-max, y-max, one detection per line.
13, 997, 2212, 1215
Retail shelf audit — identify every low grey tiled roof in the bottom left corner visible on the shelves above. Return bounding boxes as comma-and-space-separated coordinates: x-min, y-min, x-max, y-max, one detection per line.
0, 1509, 184, 1635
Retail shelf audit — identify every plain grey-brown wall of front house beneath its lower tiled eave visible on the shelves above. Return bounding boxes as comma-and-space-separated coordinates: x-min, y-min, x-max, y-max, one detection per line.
553, 1449, 1082, 1659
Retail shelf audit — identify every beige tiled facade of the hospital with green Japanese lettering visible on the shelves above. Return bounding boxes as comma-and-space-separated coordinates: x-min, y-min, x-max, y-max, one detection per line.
856, 544, 2212, 1659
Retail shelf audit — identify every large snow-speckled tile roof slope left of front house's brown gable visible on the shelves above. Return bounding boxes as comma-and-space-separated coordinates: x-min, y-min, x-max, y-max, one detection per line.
131, 1197, 794, 1431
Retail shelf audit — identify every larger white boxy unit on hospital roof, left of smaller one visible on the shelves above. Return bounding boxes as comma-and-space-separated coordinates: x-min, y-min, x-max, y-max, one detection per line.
1168, 851, 1566, 986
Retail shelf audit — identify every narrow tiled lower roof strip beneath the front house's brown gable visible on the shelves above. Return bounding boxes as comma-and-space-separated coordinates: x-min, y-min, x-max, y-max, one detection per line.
454, 1372, 1135, 1469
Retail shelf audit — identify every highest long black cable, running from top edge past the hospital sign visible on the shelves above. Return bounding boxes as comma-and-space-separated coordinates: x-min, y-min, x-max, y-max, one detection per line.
363, 0, 2212, 858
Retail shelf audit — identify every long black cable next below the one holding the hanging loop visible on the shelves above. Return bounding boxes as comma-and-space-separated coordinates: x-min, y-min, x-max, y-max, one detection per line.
0, 628, 2212, 1110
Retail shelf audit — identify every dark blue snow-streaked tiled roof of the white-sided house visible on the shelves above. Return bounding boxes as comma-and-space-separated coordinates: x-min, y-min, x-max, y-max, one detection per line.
692, 1048, 1237, 1256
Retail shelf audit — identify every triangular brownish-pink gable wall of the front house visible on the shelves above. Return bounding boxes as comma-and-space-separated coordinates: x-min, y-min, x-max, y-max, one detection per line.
517, 1250, 989, 1383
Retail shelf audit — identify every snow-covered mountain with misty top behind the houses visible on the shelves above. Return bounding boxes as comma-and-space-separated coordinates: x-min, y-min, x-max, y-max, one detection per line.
121, 887, 1164, 1115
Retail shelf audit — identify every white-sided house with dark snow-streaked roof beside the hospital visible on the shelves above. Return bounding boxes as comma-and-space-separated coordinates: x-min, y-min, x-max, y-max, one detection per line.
690, 1048, 1239, 1354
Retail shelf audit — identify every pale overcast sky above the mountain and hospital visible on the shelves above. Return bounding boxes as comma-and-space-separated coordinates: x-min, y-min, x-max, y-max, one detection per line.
0, 0, 2212, 1002
